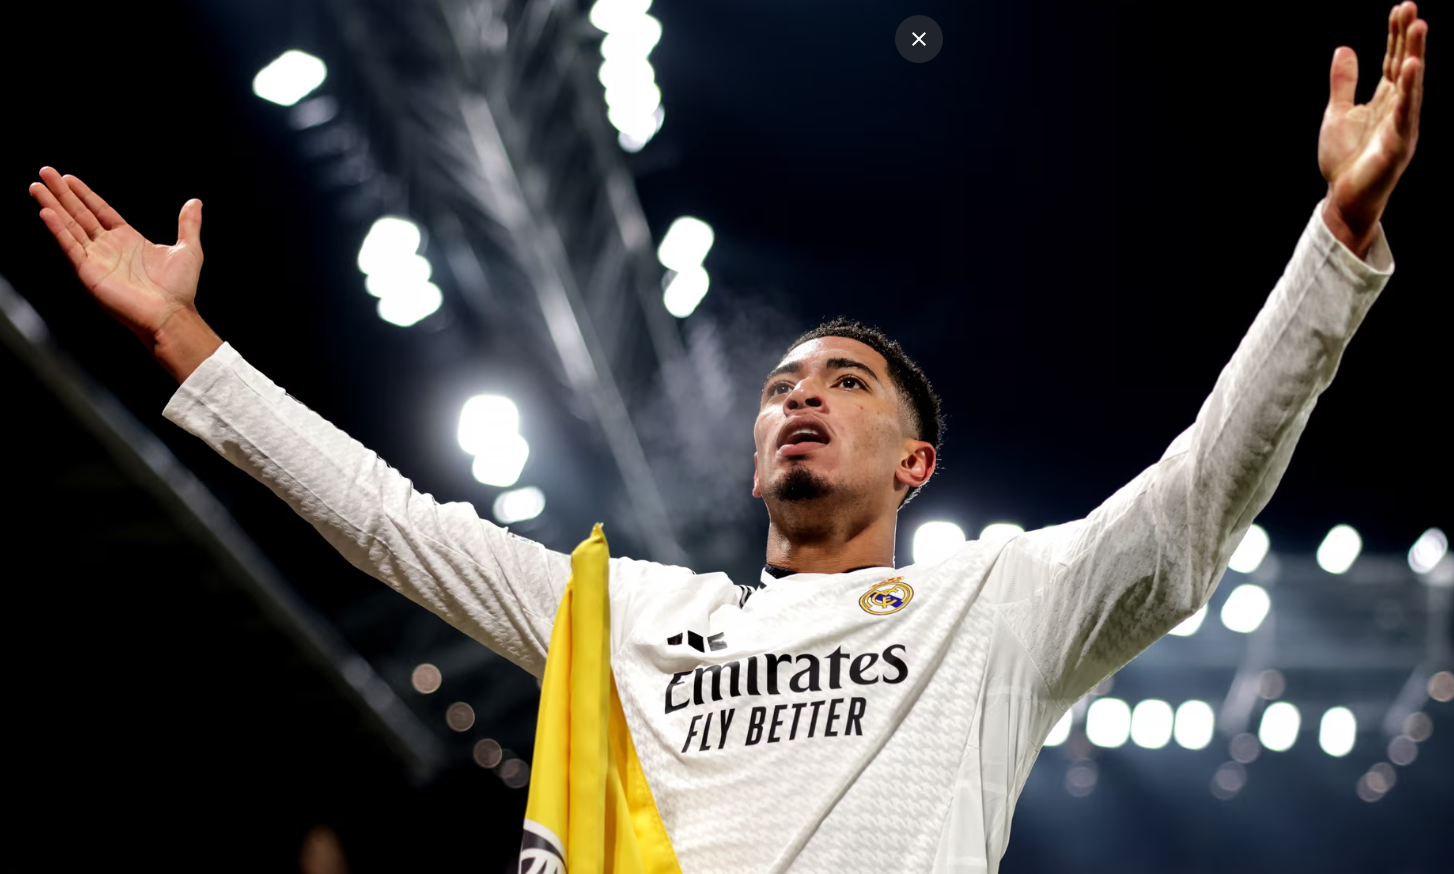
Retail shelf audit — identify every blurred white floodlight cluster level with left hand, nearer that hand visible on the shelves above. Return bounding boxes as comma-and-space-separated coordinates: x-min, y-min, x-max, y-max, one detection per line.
358, 215, 445, 327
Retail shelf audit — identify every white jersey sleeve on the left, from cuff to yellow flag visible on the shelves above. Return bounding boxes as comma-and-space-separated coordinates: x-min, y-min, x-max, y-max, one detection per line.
163, 343, 570, 676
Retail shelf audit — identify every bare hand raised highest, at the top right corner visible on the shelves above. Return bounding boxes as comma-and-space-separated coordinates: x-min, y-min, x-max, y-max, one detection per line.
1317, 3, 1429, 257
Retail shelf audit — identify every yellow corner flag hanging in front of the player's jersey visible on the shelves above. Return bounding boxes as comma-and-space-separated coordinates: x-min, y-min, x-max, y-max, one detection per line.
521, 522, 682, 874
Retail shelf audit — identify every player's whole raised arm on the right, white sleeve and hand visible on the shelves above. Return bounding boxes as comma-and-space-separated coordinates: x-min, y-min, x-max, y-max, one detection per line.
993, 3, 1426, 700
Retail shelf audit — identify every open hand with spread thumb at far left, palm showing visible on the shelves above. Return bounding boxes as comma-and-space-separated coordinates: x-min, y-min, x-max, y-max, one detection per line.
31, 167, 202, 342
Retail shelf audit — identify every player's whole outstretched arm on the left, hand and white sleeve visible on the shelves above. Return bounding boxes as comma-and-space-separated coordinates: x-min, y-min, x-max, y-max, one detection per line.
31, 167, 584, 675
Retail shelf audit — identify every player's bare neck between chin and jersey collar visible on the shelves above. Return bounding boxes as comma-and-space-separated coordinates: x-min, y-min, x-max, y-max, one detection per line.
768, 505, 897, 573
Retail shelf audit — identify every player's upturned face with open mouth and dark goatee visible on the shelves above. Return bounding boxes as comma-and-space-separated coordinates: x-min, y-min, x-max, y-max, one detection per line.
752, 337, 912, 500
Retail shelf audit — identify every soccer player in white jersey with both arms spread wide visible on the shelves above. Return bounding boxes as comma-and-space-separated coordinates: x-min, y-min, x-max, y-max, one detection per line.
31, 3, 1428, 874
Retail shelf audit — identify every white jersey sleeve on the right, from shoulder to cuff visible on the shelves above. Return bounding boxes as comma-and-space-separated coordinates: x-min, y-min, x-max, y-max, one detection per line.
993, 197, 1393, 704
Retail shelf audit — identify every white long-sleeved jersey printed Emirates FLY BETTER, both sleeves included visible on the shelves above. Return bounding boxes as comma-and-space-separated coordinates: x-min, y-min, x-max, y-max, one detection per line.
164, 205, 1393, 874
